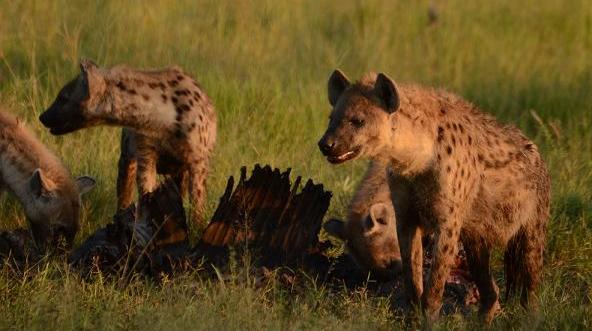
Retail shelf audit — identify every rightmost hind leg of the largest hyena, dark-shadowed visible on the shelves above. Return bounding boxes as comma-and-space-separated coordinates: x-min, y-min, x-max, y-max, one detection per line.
504, 220, 546, 307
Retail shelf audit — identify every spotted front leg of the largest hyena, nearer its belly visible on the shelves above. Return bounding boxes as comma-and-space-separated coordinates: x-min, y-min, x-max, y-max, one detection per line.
421, 203, 463, 321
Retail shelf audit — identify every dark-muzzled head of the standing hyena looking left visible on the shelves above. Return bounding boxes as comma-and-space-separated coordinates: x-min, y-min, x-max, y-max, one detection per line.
39, 59, 106, 135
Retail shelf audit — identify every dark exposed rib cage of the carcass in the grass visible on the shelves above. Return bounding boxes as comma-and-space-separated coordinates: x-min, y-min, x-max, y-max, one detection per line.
197, 165, 331, 266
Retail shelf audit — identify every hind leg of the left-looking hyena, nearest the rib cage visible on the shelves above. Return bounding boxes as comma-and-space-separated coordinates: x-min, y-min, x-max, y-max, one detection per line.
188, 158, 209, 224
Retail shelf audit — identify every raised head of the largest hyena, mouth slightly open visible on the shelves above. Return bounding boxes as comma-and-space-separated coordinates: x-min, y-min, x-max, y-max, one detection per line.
318, 69, 399, 163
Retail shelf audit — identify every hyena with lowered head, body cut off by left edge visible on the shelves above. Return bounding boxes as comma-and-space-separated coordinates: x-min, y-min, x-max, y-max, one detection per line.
0, 111, 95, 249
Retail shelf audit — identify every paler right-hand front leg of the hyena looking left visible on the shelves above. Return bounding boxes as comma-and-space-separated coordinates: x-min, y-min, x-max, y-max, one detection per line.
136, 134, 158, 196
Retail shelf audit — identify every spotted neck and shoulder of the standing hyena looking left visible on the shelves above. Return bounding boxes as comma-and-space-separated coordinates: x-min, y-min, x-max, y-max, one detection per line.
96, 69, 181, 136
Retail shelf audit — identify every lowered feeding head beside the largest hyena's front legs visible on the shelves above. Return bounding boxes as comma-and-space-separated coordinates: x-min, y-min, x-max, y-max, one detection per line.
323, 203, 401, 277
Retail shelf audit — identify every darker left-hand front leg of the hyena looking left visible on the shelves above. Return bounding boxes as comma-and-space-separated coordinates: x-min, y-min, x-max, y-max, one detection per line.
117, 129, 138, 209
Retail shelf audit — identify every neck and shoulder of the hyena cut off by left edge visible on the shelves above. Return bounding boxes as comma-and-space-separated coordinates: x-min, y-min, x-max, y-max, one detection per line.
0, 112, 74, 201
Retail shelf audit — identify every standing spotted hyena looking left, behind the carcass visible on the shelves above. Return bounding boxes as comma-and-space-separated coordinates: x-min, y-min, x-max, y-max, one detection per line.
39, 60, 216, 226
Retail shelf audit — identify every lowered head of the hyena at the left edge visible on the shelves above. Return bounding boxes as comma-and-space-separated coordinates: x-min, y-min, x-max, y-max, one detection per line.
23, 169, 95, 248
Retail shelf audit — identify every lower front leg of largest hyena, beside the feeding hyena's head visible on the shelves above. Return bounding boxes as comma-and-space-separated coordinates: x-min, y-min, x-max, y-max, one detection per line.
397, 218, 423, 304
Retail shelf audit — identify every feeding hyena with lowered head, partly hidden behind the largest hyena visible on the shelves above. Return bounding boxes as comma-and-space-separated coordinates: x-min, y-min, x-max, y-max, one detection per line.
324, 162, 401, 277
